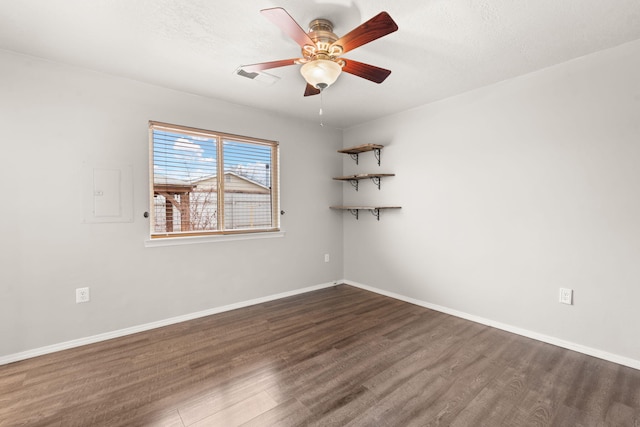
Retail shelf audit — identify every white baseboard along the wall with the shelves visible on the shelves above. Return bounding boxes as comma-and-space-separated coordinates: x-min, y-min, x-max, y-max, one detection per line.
342, 280, 640, 370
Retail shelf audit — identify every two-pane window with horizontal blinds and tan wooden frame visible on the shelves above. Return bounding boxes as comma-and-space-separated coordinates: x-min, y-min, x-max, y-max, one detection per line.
149, 122, 280, 238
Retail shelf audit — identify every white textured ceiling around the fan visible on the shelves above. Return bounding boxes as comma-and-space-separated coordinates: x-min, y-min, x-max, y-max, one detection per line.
0, 0, 640, 128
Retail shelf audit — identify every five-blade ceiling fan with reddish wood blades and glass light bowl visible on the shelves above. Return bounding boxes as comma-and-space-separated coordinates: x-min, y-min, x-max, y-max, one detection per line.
240, 7, 398, 96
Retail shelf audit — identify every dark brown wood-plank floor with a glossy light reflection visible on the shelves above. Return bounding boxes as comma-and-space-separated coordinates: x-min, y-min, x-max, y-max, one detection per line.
0, 285, 640, 427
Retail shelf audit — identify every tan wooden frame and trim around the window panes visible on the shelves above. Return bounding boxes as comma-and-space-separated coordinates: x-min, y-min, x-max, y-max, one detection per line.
151, 120, 280, 239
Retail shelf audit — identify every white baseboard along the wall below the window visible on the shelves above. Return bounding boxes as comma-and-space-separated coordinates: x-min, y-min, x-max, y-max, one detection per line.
0, 280, 343, 365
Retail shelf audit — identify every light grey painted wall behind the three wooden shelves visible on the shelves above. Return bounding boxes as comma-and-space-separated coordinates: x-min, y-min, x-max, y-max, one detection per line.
344, 41, 640, 366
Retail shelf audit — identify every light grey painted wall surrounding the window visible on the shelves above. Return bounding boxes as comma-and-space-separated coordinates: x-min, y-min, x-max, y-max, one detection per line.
0, 51, 343, 356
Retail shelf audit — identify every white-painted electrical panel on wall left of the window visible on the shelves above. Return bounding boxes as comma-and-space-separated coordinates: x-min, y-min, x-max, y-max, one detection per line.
83, 166, 133, 223
